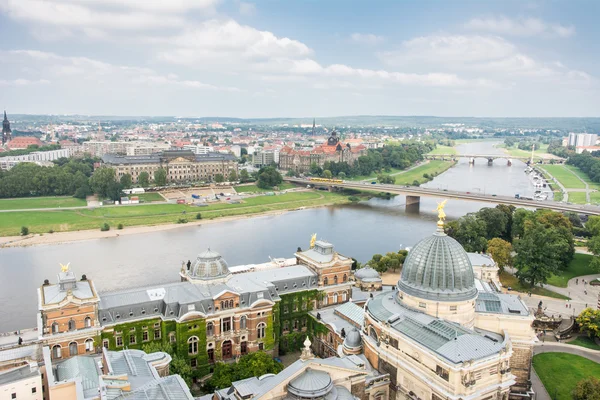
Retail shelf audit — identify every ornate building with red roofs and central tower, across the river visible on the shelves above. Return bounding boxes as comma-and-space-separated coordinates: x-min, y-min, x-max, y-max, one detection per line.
279, 130, 367, 172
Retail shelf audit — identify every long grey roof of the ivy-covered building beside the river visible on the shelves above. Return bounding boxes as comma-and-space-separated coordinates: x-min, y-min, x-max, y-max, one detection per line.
98, 265, 317, 325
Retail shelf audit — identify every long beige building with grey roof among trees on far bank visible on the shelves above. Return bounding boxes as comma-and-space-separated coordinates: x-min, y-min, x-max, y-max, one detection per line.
102, 150, 238, 183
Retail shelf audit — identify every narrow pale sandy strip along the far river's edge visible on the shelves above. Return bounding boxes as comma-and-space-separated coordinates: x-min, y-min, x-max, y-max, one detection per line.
0, 206, 300, 248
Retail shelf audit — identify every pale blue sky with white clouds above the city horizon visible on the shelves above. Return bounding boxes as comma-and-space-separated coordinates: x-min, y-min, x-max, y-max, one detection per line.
0, 0, 600, 118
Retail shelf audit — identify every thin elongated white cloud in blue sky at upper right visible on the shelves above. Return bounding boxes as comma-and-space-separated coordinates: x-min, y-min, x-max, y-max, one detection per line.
465, 16, 575, 37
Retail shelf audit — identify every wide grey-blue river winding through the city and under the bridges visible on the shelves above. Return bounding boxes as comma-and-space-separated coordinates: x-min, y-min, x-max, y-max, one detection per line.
0, 142, 534, 332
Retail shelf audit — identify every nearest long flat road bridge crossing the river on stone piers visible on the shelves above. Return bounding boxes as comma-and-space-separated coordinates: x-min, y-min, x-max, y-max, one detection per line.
284, 177, 600, 215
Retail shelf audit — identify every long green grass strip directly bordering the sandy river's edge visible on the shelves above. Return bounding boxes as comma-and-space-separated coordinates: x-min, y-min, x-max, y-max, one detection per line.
0, 191, 349, 236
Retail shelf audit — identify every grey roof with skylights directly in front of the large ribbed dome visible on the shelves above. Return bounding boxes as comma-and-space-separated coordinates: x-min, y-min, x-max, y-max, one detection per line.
366, 293, 506, 364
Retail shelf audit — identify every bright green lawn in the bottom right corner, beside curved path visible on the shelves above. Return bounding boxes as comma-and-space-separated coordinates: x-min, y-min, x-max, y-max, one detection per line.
533, 353, 600, 400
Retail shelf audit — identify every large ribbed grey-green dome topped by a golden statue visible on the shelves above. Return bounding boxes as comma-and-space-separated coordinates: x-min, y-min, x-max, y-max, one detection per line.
398, 228, 477, 301
